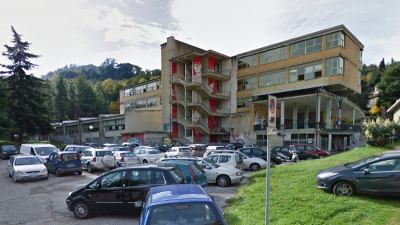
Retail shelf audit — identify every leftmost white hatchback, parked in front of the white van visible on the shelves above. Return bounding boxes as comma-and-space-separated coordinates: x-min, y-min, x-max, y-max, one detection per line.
7, 155, 49, 183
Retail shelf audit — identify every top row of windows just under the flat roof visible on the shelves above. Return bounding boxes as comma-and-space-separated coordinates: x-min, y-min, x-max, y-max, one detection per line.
238, 32, 344, 69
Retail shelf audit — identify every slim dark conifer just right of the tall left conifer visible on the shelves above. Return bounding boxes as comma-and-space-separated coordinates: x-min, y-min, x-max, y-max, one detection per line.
54, 75, 71, 121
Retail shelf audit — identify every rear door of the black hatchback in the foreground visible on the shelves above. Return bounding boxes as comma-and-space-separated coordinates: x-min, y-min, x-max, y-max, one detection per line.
123, 168, 152, 208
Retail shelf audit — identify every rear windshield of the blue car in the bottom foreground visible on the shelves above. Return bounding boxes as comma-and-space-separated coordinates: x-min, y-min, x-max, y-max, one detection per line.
149, 202, 222, 225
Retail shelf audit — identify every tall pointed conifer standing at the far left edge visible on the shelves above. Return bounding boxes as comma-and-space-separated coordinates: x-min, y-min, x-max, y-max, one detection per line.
0, 27, 50, 144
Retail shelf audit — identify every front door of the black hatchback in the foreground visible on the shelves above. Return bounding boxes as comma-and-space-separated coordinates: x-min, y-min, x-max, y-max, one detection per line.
90, 170, 127, 210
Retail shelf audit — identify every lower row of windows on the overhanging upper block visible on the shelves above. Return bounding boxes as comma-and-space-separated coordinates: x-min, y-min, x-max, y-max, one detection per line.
237, 57, 344, 91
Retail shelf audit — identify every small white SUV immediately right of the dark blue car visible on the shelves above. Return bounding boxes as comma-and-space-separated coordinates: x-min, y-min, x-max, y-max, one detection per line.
81, 148, 117, 173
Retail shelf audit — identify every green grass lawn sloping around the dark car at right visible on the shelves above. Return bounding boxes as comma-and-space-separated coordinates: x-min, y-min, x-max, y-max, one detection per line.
224, 147, 400, 225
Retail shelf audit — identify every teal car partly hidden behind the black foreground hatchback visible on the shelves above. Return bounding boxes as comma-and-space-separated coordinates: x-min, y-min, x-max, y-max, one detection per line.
157, 160, 207, 188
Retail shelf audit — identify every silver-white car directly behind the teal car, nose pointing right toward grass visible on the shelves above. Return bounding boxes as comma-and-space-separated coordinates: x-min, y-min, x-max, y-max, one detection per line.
160, 157, 243, 187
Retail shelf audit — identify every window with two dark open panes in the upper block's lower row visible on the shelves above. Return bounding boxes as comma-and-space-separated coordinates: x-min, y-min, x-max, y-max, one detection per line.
289, 62, 322, 82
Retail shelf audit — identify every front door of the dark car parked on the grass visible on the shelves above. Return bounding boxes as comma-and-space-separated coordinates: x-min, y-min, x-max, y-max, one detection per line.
356, 157, 400, 194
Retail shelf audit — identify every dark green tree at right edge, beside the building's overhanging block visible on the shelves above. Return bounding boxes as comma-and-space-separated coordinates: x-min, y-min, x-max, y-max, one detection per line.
377, 62, 400, 109
